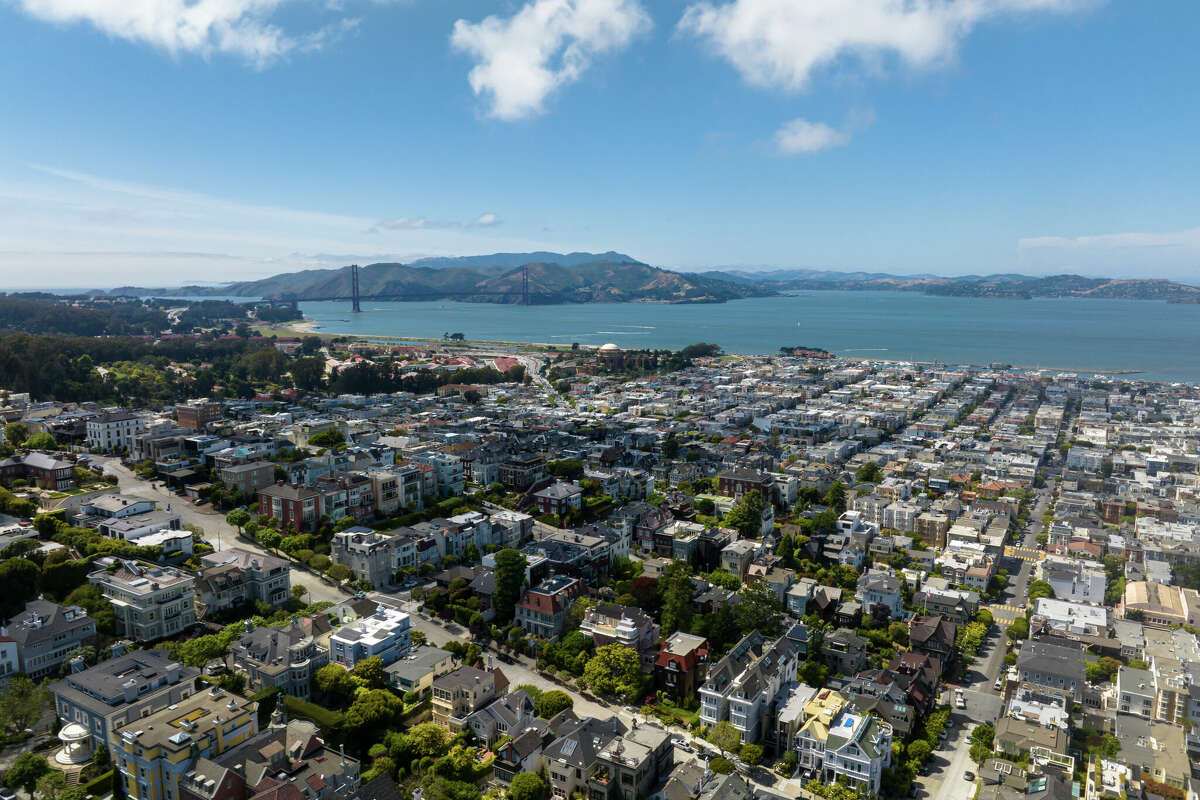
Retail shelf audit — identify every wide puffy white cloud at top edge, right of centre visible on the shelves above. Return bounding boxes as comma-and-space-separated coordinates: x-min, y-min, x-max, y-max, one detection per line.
679, 0, 1094, 90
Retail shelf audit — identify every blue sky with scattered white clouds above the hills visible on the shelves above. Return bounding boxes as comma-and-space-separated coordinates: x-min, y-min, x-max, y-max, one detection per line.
0, 0, 1200, 289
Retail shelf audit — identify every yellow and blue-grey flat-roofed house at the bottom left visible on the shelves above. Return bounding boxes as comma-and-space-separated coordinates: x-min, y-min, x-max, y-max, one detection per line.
109, 687, 258, 800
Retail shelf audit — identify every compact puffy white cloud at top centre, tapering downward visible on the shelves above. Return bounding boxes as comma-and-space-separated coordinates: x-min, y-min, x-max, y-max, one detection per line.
450, 0, 653, 120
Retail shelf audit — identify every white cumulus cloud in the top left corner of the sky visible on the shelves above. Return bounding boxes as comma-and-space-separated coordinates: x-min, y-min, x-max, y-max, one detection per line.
11, 0, 358, 67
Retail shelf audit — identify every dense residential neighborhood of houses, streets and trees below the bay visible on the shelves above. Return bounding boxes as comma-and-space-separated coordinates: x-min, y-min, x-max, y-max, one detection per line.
0, 339, 1200, 800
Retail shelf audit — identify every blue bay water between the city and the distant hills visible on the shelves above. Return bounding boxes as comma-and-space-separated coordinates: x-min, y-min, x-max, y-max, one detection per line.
300, 291, 1200, 383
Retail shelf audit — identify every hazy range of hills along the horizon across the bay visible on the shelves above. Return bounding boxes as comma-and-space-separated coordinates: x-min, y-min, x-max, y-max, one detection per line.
100, 251, 1200, 305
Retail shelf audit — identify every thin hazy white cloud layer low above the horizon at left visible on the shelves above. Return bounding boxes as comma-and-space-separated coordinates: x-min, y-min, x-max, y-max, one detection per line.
7, 164, 549, 287
